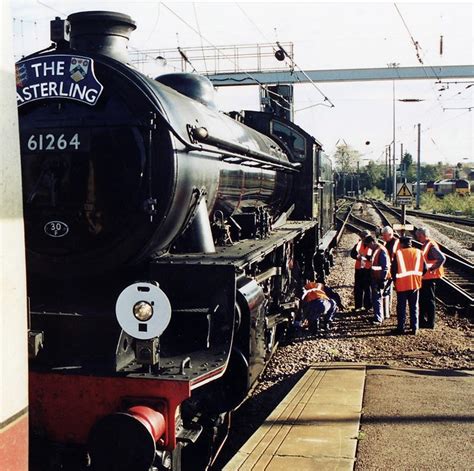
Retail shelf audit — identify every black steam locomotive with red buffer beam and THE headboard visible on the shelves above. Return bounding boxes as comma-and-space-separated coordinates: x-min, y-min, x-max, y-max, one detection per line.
16, 11, 335, 471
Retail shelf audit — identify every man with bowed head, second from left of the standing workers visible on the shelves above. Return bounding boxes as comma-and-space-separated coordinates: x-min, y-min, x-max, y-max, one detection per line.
364, 236, 390, 325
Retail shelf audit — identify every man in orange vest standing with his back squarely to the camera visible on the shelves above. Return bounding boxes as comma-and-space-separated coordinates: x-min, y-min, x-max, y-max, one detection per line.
391, 237, 426, 335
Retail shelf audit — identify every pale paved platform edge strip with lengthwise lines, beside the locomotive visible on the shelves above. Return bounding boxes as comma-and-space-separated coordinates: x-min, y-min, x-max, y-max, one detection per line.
224, 363, 365, 471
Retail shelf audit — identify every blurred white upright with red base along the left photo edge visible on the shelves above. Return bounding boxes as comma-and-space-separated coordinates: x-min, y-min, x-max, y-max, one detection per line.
0, 1, 28, 471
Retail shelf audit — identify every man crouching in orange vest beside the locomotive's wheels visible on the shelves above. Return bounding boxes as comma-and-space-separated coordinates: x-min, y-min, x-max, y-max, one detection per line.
301, 281, 344, 333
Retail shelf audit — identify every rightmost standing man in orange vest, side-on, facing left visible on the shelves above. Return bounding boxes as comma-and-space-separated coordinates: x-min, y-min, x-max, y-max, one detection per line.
415, 227, 446, 329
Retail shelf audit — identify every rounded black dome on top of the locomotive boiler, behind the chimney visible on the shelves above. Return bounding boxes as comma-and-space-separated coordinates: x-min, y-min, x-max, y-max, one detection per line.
155, 73, 217, 109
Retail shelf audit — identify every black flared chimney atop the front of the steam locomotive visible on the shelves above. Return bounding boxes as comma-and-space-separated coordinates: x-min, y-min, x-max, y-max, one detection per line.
67, 11, 136, 62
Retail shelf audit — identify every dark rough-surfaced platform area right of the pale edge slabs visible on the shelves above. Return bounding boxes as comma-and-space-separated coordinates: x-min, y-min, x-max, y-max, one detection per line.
358, 366, 474, 471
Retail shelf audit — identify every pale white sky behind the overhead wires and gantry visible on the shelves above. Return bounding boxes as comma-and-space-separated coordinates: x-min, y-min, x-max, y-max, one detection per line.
11, 0, 474, 164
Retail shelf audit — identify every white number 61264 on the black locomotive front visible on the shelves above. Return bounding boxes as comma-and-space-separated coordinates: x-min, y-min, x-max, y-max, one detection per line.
21, 129, 90, 154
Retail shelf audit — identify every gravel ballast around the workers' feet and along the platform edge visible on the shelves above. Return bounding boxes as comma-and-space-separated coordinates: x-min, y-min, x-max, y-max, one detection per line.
214, 233, 474, 469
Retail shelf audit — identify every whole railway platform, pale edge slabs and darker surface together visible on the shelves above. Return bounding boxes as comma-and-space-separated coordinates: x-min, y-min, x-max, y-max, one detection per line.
223, 363, 474, 471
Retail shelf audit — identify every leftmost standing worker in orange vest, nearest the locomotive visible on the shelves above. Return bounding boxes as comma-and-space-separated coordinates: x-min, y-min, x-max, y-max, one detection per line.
351, 230, 372, 311
